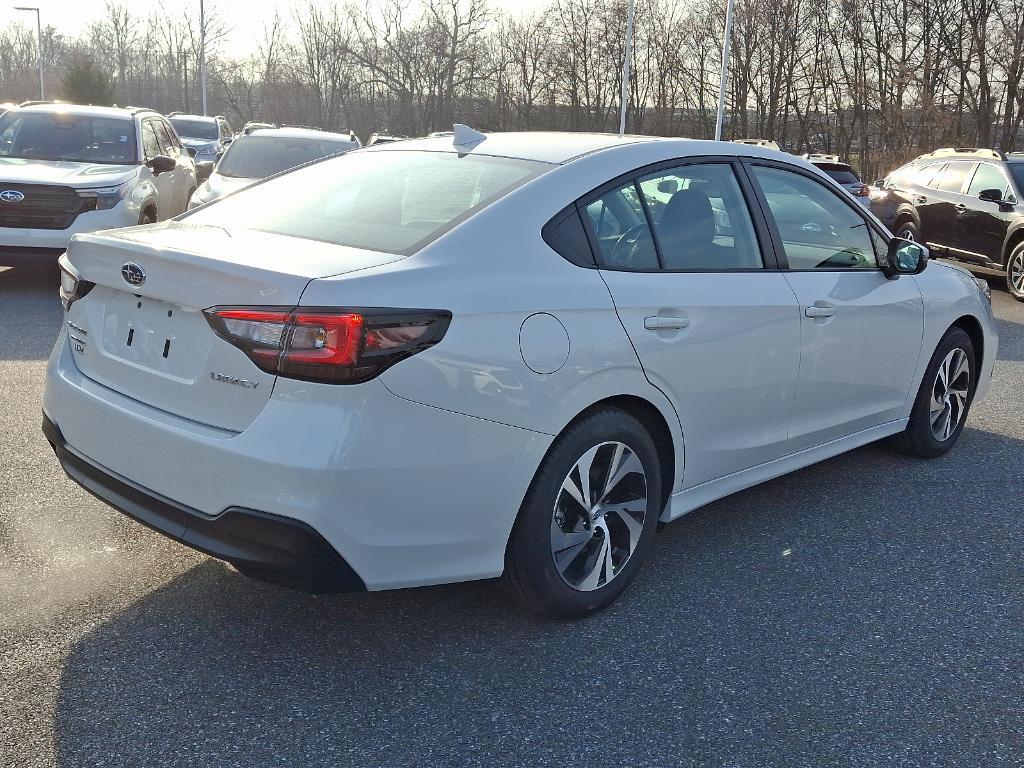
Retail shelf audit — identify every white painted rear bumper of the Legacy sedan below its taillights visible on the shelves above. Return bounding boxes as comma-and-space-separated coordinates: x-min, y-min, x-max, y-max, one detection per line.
43, 332, 553, 590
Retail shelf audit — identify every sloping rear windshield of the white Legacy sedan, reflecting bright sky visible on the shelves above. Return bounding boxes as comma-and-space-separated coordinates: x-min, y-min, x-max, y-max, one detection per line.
187, 151, 552, 254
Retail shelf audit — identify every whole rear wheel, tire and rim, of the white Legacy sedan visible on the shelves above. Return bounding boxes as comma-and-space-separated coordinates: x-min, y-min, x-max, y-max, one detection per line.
503, 409, 662, 617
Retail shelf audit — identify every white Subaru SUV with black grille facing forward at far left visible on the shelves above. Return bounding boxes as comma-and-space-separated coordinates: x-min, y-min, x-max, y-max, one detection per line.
0, 103, 196, 250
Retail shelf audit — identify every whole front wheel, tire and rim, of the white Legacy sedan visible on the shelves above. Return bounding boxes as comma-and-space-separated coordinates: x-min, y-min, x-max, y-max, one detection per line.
896, 328, 977, 459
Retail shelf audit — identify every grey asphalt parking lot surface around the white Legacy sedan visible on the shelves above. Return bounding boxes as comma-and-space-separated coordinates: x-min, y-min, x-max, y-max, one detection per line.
0, 255, 1024, 768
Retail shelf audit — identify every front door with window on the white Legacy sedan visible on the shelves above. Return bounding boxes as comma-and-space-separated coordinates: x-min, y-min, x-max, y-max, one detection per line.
749, 162, 924, 451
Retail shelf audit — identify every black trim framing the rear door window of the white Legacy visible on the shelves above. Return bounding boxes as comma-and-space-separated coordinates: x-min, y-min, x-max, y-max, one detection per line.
569, 155, 782, 274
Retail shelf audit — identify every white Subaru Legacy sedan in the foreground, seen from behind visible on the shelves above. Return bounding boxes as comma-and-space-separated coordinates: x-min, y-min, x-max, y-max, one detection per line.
44, 131, 997, 616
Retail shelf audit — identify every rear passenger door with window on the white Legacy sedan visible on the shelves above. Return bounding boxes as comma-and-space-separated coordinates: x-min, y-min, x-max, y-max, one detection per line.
582, 159, 800, 487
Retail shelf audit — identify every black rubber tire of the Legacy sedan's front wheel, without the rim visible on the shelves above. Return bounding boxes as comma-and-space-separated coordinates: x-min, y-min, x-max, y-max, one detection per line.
895, 328, 978, 459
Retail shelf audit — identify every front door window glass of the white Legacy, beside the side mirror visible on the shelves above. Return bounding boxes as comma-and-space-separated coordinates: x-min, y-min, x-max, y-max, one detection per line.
752, 166, 878, 269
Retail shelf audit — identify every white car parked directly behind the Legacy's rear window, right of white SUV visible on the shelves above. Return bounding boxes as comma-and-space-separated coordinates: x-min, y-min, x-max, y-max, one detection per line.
188, 128, 360, 208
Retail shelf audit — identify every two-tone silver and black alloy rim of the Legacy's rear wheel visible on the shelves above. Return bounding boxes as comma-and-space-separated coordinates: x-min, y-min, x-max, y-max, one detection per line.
551, 442, 647, 592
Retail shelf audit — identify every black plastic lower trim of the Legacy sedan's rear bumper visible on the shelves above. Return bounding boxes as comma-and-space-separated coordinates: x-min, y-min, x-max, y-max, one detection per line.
43, 414, 367, 593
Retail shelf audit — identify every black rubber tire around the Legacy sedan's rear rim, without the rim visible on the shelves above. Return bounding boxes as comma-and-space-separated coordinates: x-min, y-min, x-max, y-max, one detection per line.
502, 408, 663, 618
